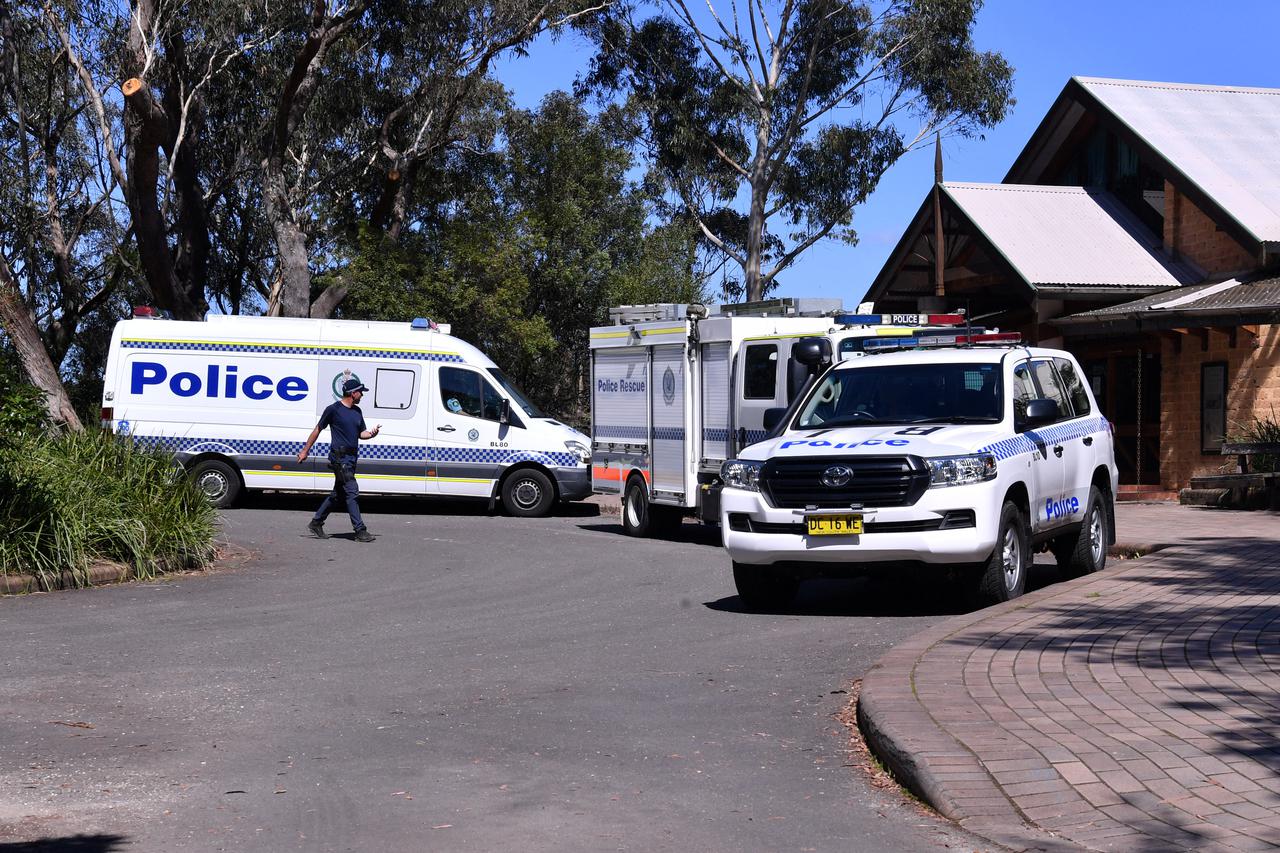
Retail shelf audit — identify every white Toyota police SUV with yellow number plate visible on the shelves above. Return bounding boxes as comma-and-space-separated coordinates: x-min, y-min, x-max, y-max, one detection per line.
721, 334, 1117, 607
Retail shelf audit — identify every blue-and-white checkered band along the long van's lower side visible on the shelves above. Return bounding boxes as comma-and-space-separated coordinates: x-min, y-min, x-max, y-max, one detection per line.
133, 435, 579, 467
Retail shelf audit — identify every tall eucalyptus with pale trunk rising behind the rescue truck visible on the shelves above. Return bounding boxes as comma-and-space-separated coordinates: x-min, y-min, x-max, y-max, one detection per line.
581, 0, 1014, 300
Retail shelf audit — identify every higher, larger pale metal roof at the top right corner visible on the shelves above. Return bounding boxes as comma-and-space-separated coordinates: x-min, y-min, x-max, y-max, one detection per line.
1074, 77, 1280, 243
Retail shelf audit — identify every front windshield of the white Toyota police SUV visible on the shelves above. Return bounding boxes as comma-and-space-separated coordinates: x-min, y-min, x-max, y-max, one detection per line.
795, 364, 1004, 429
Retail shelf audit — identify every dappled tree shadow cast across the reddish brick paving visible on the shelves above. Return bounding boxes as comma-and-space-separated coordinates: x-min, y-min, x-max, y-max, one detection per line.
948, 538, 1280, 776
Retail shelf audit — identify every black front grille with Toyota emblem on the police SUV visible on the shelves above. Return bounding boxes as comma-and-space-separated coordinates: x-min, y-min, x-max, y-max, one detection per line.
760, 456, 929, 508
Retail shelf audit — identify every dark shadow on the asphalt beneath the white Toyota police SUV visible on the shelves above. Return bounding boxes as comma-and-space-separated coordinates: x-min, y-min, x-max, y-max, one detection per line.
704, 560, 1061, 617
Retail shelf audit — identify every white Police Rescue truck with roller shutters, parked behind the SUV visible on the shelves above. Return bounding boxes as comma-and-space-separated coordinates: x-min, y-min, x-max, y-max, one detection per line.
590, 298, 980, 535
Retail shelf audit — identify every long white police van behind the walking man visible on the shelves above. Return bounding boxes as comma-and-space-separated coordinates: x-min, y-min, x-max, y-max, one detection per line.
102, 309, 591, 516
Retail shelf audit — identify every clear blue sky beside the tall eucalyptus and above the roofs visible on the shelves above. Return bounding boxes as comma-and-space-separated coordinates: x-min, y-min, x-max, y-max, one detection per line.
498, 0, 1280, 307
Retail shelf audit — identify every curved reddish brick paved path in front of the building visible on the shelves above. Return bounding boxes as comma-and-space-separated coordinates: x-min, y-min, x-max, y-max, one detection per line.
859, 505, 1280, 852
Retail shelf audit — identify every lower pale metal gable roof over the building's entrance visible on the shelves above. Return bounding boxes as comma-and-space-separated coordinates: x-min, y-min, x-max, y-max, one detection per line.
942, 183, 1201, 291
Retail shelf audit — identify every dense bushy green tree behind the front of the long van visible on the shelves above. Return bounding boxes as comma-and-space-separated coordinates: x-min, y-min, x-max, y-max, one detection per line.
330, 92, 701, 423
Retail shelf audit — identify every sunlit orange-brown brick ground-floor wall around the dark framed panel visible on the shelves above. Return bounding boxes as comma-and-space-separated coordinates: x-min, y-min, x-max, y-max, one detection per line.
1160, 325, 1280, 489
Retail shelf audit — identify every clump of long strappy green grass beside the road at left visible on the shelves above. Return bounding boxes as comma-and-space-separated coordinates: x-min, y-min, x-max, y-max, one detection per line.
0, 429, 216, 589
